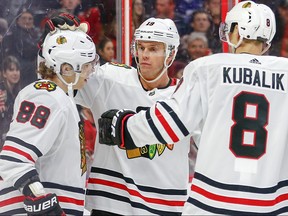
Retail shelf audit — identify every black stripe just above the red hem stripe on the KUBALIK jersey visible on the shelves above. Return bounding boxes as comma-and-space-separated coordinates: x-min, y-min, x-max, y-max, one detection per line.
194, 172, 288, 194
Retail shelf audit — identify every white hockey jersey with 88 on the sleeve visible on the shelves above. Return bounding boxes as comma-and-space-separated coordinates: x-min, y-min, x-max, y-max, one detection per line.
0, 80, 87, 215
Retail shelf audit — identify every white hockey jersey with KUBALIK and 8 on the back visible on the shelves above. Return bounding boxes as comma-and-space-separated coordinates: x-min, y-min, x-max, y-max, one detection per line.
127, 54, 288, 215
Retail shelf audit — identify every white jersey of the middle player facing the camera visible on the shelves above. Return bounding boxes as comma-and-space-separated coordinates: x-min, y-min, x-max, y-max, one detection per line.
75, 63, 190, 215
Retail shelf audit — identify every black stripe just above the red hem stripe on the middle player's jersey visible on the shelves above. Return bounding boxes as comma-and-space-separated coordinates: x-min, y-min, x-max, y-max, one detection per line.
91, 167, 187, 196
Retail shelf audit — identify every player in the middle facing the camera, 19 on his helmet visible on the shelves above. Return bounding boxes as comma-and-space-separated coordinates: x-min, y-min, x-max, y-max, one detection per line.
43, 15, 190, 216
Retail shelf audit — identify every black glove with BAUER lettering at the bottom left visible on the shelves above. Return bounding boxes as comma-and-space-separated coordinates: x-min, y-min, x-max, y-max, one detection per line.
24, 194, 66, 216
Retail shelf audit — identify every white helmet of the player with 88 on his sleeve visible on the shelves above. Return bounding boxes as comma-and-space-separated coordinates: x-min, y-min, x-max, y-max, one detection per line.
42, 29, 99, 73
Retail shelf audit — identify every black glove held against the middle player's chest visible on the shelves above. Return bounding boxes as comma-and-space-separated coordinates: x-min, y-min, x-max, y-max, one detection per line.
98, 109, 135, 149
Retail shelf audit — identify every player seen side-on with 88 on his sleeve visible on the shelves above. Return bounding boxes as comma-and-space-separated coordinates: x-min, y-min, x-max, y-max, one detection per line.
0, 30, 99, 215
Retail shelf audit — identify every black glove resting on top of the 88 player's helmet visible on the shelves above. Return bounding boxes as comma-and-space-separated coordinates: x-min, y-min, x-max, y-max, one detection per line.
38, 13, 89, 52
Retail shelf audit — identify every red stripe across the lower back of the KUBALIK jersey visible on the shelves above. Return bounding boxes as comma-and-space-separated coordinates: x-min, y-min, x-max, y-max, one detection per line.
191, 185, 288, 206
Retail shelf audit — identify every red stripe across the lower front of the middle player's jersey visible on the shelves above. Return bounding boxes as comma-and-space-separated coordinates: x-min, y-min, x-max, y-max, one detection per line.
88, 178, 185, 206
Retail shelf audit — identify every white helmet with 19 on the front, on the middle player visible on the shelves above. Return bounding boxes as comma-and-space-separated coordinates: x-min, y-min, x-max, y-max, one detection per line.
133, 17, 180, 82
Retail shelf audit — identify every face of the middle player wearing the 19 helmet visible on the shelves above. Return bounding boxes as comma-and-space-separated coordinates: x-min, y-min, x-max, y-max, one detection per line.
137, 41, 165, 80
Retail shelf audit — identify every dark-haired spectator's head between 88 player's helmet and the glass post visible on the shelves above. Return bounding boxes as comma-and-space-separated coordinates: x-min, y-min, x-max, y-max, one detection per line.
97, 37, 115, 65
